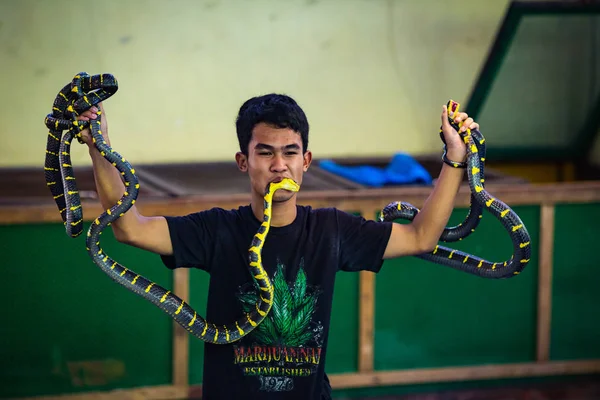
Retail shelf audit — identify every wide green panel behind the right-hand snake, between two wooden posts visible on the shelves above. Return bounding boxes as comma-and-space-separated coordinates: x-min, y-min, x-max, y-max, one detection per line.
375, 207, 539, 370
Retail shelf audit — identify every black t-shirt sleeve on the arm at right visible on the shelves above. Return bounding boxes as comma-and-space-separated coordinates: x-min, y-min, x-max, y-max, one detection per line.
338, 211, 392, 272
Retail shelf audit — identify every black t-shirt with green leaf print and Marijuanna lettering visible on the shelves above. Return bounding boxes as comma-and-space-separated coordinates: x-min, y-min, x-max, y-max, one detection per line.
162, 206, 391, 400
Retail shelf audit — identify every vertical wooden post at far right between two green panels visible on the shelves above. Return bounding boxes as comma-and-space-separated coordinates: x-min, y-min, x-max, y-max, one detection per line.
536, 204, 555, 362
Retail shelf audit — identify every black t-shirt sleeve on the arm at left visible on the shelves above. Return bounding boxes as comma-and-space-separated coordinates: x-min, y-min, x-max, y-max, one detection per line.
161, 209, 218, 272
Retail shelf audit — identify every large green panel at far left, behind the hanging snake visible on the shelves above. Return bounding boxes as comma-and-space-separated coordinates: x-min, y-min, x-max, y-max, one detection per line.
0, 224, 173, 398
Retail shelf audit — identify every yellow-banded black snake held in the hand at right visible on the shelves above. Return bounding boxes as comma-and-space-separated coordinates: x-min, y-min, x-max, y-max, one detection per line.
379, 100, 531, 279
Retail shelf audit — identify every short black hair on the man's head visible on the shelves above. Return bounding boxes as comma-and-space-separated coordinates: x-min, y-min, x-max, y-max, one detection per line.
235, 93, 309, 155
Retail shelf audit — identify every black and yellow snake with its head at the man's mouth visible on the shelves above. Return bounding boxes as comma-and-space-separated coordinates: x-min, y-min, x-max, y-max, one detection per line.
44, 72, 299, 344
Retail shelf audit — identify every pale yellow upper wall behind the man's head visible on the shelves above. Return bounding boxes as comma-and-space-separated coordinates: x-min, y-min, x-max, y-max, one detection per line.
0, 0, 508, 166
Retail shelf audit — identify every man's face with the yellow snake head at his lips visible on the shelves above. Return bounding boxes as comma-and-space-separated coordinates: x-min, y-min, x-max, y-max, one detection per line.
236, 123, 312, 202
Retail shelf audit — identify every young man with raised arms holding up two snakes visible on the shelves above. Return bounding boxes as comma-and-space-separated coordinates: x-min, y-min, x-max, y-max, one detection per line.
80, 94, 478, 400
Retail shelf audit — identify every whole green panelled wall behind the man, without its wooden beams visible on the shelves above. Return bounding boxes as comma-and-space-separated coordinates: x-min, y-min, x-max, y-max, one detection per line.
0, 204, 600, 398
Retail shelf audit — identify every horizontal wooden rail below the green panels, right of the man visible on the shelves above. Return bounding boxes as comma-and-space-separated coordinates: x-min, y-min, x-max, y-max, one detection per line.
329, 359, 600, 389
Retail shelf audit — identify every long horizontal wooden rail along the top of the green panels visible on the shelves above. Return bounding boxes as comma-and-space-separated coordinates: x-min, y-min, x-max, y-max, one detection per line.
0, 181, 600, 224
